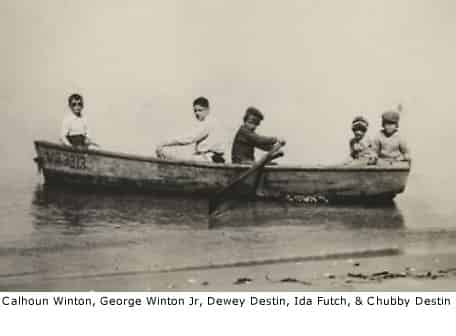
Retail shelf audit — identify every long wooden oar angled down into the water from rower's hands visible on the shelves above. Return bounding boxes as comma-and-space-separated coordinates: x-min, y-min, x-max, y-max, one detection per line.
209, 144, 283, 215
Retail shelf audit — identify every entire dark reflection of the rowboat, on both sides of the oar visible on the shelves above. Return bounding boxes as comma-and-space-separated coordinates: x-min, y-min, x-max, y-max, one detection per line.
32, 185, 404, 231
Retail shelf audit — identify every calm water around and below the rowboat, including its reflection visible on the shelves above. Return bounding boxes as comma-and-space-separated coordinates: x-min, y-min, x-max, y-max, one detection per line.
0, 163, 456, 254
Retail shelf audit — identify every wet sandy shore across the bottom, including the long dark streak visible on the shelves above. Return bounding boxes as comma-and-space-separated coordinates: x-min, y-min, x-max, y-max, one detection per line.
0, 227, 456, 291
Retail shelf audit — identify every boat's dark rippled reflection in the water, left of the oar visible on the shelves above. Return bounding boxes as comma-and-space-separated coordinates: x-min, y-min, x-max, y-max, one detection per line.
32, 185, 207, 229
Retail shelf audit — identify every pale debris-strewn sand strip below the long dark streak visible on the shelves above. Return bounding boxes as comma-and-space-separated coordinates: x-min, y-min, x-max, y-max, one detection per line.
0, 252, 456, 291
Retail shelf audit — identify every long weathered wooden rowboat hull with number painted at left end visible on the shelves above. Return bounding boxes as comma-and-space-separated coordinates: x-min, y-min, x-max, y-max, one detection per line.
35, 141, 410, 201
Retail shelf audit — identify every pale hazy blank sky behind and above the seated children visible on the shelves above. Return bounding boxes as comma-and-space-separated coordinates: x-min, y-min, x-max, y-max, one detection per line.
0, 0, 456, 169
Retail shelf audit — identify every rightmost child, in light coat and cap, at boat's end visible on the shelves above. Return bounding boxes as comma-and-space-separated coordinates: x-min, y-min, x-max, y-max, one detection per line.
373, 111, 411, 161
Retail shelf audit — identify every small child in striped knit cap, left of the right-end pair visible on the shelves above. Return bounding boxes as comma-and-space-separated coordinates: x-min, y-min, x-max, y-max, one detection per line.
350, 116, 375, 164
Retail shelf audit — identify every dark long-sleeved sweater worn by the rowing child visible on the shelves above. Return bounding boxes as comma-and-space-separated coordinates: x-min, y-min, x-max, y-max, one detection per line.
231, 125, 277, 163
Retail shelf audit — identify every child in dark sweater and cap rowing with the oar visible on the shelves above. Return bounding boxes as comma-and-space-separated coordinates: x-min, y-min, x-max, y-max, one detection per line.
231, 107, 285, 164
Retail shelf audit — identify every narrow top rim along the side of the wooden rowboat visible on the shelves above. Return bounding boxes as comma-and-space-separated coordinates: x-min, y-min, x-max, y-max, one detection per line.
34, 140, 410, 172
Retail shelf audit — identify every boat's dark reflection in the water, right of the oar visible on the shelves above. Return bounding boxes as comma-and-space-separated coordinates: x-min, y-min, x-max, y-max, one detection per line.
210, 202, 404, 229
